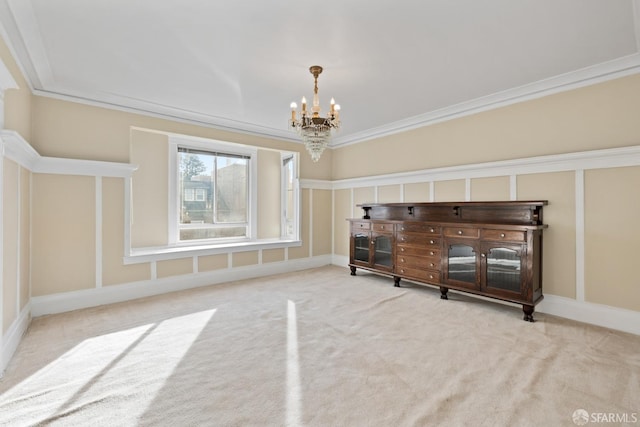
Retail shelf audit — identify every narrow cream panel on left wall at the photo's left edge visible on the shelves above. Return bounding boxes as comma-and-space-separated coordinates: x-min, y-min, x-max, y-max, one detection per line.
2, 159, 20, 333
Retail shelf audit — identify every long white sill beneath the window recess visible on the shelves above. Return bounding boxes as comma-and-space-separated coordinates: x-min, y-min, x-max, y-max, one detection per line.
123, 239, 302, 264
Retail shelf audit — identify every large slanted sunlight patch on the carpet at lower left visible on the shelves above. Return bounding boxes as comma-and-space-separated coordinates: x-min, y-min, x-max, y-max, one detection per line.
0, 309, 216, 425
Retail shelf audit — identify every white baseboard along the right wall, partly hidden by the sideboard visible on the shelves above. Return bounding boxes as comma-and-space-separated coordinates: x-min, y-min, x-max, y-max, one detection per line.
332, 255, 640, 335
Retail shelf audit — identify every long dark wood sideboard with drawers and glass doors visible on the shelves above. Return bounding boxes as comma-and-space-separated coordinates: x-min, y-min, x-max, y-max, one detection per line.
348, 200, 547, 322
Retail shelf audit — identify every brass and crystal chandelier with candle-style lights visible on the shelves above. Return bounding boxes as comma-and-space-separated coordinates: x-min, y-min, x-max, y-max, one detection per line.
290, 65, 340, 162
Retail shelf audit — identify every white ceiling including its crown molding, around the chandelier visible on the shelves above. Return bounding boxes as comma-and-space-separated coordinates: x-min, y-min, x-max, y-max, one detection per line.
0, 0, 640, 146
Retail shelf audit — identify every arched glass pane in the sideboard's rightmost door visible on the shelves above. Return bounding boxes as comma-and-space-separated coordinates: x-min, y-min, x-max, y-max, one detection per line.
485, 247, 522, 293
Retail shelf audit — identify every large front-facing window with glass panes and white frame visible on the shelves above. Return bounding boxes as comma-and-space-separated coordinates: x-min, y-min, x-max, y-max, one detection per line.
169, 137, 257, 245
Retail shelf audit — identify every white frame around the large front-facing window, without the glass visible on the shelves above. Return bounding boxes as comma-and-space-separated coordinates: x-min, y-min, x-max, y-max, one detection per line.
168, 135, 258, 246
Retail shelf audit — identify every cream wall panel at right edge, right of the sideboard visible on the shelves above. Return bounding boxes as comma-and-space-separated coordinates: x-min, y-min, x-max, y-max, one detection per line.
584, 167, 640, 311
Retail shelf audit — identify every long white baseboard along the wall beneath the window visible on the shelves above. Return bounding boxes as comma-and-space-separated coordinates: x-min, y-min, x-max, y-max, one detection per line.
31, 255, 331, 317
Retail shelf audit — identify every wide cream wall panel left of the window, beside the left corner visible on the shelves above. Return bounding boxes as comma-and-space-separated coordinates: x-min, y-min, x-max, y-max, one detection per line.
31, 174, 96, 296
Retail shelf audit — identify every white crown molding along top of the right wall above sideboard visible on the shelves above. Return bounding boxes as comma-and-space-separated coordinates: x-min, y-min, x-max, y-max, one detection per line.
331, 53, 640, 148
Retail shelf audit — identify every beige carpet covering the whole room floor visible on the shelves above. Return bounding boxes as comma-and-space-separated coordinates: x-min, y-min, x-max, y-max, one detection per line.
0, 267, 640, 427
